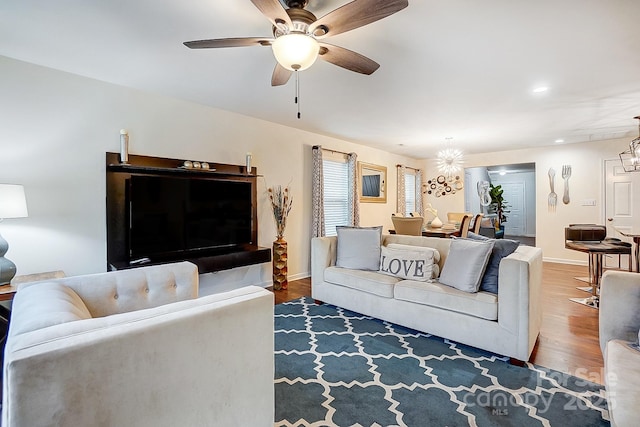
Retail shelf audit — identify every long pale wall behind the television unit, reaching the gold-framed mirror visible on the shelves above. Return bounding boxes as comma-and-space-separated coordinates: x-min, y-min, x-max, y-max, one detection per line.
0, 57, 419, 284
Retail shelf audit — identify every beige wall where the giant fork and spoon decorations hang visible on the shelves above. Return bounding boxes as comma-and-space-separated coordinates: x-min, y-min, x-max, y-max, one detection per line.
424, 137, 633, 264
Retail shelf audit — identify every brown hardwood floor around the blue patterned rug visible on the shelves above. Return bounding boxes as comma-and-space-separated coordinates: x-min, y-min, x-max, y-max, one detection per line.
274, 262, 604, 384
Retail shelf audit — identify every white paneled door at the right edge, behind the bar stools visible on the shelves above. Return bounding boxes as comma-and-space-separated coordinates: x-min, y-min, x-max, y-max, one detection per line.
605, 159, 640, 269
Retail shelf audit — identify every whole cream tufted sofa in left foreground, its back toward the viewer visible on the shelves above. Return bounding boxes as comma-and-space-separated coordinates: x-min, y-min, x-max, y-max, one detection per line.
2, 262, 274, 427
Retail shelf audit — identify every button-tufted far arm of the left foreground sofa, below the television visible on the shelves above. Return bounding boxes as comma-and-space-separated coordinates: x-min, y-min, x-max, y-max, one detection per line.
18, 262, 198, 317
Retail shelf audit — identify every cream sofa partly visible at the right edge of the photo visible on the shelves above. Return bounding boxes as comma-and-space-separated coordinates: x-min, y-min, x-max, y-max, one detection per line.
600, 271, 640, 427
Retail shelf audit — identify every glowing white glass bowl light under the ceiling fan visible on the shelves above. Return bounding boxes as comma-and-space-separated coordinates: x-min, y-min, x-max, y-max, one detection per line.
271, 33, 320, 71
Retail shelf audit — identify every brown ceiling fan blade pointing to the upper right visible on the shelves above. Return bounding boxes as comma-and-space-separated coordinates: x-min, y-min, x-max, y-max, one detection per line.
309, 0, 409, 38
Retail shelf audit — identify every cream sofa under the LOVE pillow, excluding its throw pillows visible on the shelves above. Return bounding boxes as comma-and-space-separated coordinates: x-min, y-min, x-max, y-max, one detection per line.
311, 235, 542, 361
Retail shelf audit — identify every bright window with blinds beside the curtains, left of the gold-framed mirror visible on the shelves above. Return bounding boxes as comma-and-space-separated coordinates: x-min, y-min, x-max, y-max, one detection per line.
322, 159, 349, 236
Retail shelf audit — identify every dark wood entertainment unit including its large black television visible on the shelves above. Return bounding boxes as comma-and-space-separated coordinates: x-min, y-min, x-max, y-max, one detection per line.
106, 153, 271, 273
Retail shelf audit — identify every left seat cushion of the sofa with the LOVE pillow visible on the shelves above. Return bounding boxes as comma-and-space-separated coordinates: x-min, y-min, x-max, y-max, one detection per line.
324, 267, 399, 298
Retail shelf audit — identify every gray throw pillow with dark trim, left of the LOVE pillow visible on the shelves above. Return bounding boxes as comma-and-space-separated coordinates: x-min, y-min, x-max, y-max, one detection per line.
336, 225, 382, 271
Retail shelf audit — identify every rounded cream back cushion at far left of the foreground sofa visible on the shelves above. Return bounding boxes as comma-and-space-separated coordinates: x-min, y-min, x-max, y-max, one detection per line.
10, 282, 91, 336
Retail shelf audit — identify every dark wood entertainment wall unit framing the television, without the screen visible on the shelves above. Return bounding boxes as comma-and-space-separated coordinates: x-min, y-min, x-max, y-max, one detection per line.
106, 153, 271, 273
